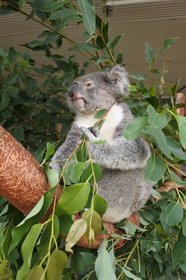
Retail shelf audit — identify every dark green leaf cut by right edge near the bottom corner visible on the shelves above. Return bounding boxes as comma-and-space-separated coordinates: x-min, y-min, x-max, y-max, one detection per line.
172, 231, 186, 269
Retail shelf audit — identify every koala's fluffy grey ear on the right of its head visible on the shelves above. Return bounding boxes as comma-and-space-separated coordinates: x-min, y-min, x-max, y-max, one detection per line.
106, 65, 129, 96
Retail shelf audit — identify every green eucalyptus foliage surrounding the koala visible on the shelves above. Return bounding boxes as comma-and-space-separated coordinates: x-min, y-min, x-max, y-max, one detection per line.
0, 0, 186, 280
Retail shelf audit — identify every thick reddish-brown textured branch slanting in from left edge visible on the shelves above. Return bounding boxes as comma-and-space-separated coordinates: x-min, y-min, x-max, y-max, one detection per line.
0, 126, 49, 214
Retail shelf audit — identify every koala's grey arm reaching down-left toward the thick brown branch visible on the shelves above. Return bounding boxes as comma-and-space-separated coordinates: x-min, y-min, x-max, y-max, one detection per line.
49, 124, 82, 171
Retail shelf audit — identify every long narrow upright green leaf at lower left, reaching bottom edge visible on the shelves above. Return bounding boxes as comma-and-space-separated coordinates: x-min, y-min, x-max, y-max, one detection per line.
16, 224, 43, 280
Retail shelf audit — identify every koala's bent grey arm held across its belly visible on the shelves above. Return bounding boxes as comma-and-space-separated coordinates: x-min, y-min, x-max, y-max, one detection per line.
89, 136, 150, 170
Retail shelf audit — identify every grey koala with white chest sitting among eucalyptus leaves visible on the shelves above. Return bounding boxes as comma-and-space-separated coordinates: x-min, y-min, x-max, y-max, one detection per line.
50, 65, 152, 223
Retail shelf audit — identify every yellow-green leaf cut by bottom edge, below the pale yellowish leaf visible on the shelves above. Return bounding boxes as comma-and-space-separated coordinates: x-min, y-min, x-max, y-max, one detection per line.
47, 249, 68, 280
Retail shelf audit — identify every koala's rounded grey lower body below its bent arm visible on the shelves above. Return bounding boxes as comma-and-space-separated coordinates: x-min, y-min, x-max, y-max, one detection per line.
98, 169, 153, 223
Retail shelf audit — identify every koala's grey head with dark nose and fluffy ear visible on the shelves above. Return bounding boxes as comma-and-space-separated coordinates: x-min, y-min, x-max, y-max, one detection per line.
67, 66, 129, 115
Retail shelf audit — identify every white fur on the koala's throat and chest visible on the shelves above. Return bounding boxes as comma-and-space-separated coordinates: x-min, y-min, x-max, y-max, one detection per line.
75, 104, 123, 143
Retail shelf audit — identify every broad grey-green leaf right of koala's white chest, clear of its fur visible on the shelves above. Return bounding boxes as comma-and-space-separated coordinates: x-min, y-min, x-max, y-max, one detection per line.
147, 105, 169, 129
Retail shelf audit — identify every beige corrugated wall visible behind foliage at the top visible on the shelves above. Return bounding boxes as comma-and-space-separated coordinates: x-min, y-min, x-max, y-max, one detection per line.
0, 0, 186, 85
